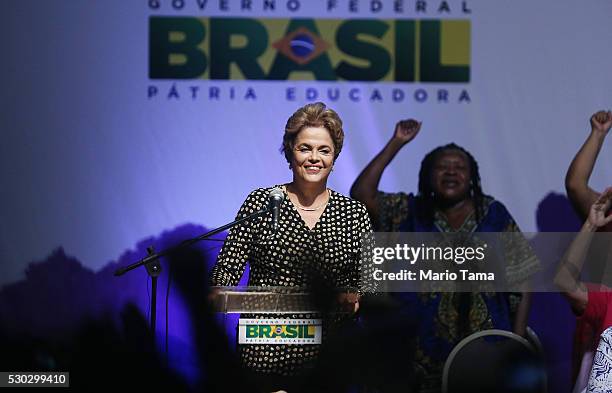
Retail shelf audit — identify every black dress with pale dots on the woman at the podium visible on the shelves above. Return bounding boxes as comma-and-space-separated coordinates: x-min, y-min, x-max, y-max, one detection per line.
211, 188, 372, 375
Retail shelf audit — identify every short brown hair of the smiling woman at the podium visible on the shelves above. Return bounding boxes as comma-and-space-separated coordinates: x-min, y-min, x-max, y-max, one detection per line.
281, 102, 344, 163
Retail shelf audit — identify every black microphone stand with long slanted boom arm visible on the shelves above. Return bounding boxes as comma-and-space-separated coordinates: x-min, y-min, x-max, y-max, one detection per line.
115, 206, 270, 335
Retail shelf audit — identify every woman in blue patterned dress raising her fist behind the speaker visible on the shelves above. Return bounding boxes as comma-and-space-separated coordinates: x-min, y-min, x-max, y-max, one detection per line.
351, 119, 538, 393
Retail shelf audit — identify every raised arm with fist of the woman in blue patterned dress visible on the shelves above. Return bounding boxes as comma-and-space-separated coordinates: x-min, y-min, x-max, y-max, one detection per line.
351, 119, 422, 226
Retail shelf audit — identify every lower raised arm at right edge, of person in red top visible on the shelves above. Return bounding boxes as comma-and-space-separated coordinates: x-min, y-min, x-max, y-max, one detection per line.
555, 187, 612, 315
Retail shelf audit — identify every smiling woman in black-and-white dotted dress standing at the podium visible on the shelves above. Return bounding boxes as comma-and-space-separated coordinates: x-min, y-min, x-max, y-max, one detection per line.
211, 102, 372, 391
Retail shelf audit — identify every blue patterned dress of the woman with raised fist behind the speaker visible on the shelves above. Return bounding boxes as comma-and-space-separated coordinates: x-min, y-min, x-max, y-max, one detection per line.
377, 192, 539, 393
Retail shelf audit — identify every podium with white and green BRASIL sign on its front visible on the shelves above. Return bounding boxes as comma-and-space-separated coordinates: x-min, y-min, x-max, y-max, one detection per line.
211, 287, 359, 345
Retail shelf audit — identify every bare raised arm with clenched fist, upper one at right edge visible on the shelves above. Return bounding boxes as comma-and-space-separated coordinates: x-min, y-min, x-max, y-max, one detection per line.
565, 111, 612, 219
